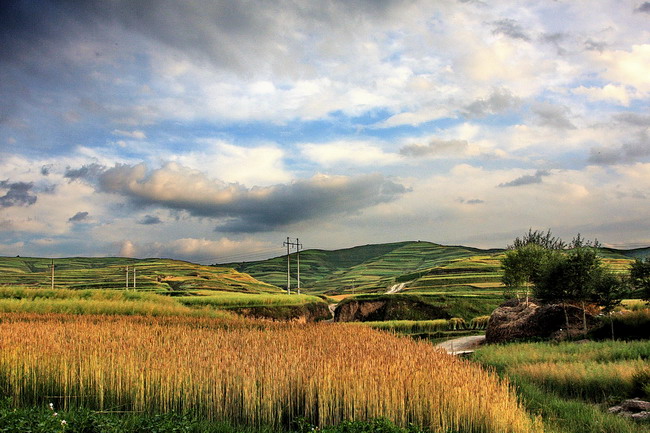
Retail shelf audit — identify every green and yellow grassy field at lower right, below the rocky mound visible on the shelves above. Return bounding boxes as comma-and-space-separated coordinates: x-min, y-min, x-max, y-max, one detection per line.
472, 341, 650, 433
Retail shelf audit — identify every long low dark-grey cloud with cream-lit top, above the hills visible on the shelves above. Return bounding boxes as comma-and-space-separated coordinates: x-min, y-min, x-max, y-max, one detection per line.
98, 164, 408, 232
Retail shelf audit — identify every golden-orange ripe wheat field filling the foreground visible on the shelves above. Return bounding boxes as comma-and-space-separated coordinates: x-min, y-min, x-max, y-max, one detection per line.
0, 314, 542, 433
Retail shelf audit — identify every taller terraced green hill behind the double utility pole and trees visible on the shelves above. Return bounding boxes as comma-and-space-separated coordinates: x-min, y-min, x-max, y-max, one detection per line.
218, 241, 650, 296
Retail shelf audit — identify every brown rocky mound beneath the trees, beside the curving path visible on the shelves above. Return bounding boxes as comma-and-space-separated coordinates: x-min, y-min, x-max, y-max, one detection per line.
485, 299, 595, 343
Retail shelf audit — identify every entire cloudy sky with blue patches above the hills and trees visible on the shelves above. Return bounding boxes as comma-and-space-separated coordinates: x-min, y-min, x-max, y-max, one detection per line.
0, 0, 650, 263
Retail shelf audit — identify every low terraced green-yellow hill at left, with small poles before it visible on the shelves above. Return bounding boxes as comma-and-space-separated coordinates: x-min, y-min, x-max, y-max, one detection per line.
0, 257, 280, 293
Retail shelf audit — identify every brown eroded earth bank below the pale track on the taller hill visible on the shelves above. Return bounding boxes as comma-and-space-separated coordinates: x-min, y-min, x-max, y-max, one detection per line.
334, 295, 451, 322
